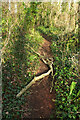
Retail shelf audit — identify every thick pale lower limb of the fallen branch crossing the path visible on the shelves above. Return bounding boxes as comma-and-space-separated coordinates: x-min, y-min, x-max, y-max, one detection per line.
16, 69, 52, 97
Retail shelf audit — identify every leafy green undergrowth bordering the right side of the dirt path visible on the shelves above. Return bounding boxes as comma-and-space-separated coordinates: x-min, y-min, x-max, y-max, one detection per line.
39, 26, 80, 120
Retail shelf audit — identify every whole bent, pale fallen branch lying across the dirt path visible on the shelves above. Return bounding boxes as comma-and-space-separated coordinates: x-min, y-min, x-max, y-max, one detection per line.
16, 46, 53, 97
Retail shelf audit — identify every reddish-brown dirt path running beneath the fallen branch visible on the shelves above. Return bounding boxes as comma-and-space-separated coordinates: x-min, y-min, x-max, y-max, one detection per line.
23, 39, 55, 118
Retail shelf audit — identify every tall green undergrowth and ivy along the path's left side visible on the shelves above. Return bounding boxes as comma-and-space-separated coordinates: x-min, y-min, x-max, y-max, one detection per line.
2, 6, 43, 117
